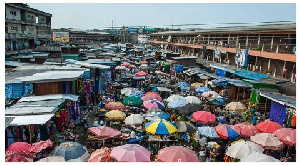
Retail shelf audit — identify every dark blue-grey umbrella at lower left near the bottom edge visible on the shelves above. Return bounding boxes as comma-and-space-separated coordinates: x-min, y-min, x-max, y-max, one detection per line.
51, 141, 89, 161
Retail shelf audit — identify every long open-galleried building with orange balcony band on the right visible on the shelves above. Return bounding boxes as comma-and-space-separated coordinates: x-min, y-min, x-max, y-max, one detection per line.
148, 23, 296, 80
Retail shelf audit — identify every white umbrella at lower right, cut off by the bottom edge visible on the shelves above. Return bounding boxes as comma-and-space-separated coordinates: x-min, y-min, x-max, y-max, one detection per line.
240, 151, 280, 162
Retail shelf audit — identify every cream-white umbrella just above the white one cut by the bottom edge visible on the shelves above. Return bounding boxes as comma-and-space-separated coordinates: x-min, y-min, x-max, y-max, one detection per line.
226, 141, 264, 159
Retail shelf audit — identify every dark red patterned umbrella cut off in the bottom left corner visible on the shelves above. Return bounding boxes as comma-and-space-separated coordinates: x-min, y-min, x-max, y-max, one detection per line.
5, 151, 33, 162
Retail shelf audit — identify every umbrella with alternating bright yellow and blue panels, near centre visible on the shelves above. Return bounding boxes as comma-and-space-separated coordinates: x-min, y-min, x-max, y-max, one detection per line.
145, 120, 177, 135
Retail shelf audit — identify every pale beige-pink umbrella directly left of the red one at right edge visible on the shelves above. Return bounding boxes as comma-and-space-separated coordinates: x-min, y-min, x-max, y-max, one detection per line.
250, 133, 283, 150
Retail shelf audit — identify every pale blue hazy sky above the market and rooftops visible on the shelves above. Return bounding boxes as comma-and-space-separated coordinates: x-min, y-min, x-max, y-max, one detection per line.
28, 3, 296, 29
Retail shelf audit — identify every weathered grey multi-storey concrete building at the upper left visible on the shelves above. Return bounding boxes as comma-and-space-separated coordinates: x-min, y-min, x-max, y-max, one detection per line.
5, 3, 52, 52
